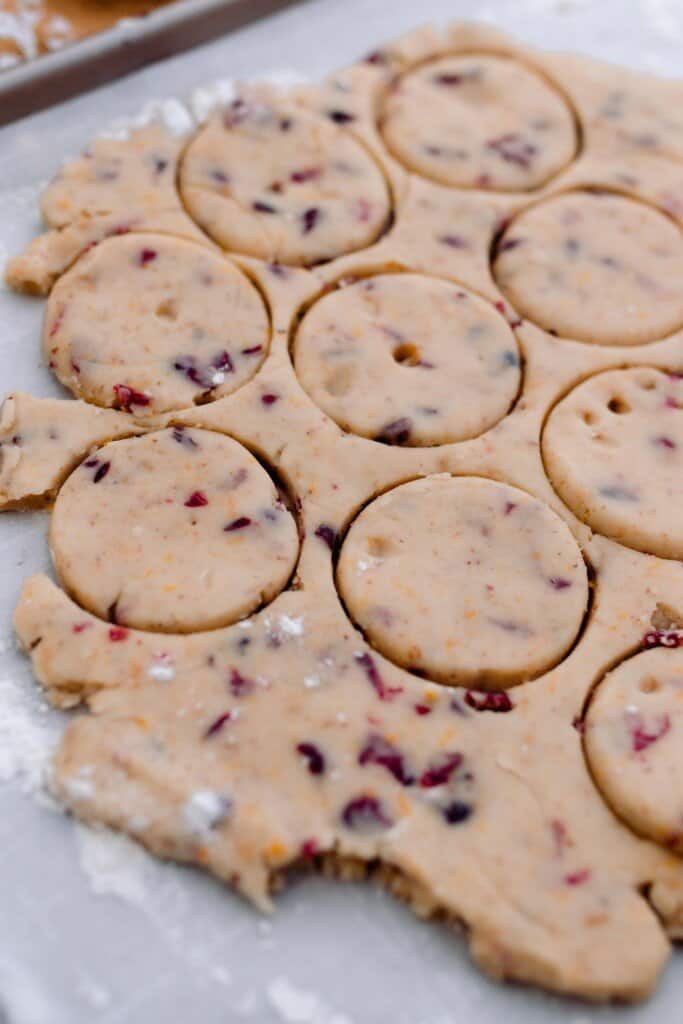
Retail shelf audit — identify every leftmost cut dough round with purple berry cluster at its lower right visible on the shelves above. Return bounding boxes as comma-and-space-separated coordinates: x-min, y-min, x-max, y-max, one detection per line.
43, 234, 269, 418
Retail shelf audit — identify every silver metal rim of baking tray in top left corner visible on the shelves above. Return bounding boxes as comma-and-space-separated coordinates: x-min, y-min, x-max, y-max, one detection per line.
0, 0, 301, 125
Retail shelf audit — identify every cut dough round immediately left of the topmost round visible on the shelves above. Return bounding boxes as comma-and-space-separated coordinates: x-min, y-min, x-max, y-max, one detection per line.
180, 98, 391, 266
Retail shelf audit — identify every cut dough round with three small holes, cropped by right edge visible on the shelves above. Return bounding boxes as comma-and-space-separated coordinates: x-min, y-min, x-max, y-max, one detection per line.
542, 367, 683, 558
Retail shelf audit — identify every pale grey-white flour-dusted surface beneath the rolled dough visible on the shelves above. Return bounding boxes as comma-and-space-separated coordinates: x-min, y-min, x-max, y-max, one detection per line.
0, 0, 683, 1024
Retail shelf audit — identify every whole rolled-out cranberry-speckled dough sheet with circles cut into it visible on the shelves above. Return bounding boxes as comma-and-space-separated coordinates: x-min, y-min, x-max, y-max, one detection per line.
5, 25, 683, 1000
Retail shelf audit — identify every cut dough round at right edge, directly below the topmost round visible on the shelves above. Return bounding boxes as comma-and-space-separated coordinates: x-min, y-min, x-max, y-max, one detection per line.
494, 191, 683, 345
